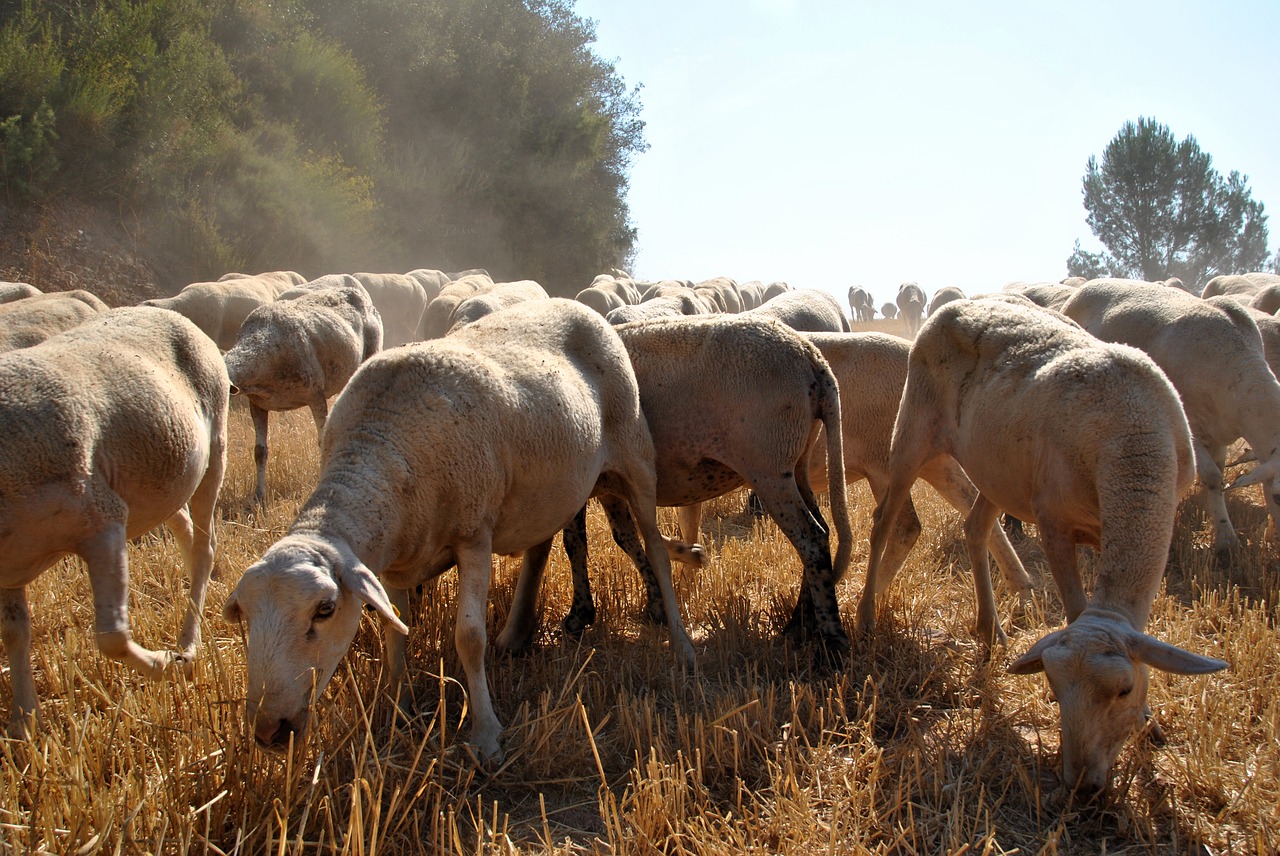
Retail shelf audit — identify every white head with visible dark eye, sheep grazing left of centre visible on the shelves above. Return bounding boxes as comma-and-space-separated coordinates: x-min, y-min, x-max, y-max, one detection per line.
223, 534, 408, 751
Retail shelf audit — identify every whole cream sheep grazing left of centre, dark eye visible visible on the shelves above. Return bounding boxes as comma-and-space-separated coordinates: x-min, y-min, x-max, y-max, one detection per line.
223, 298, 694, 759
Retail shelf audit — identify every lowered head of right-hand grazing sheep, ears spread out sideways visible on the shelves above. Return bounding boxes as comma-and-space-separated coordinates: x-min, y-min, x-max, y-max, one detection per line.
1009, 610, 1228, 796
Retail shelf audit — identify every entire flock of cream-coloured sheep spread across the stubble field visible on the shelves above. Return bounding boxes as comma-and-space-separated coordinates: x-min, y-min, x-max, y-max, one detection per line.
0, 263, 1280, 793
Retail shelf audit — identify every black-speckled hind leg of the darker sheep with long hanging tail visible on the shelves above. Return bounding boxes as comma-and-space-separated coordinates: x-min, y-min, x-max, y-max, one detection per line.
751, 479, 850, 654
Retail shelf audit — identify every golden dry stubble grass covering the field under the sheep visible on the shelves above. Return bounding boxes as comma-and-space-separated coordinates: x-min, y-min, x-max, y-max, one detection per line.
0, 401, 1280, 853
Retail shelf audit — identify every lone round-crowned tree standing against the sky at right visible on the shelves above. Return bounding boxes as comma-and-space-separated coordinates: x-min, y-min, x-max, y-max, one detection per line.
1068, 118, 1267, 284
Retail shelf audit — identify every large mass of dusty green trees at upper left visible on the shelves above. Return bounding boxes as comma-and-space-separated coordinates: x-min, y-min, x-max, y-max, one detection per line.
0, 0, 645, 293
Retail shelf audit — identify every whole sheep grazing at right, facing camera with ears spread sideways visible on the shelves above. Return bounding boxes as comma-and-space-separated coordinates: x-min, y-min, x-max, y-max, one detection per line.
858, 299, 1228, 795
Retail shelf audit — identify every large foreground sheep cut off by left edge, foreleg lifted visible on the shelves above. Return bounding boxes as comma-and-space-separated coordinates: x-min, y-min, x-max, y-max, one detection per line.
0, 307, 229, 737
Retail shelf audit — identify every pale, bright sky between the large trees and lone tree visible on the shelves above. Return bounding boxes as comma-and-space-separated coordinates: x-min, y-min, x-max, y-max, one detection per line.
576, 0, 1280, 306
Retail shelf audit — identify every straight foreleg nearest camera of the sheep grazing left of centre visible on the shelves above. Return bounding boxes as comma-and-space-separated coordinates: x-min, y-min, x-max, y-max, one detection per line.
453, 532, 502, 761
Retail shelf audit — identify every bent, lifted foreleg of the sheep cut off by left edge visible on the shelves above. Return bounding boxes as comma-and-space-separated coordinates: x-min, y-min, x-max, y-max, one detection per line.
77, 522, 177, 678
